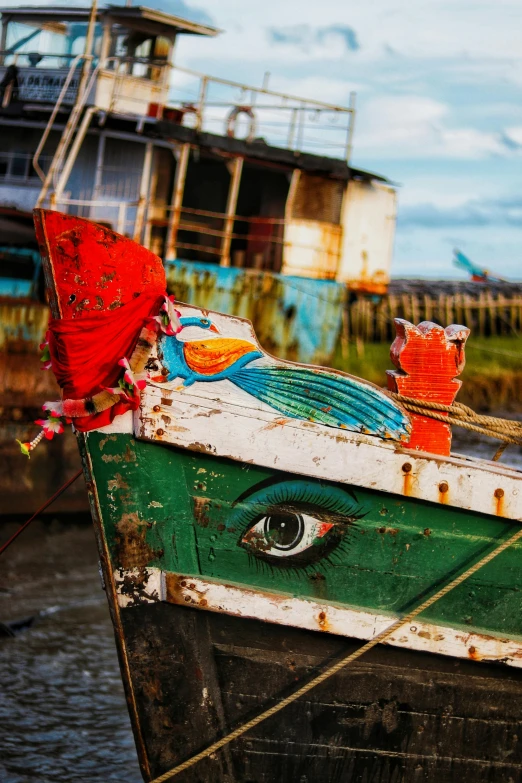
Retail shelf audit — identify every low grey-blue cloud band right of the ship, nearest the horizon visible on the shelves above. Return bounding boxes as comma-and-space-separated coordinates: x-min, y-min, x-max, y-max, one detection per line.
397, 196, 522, 229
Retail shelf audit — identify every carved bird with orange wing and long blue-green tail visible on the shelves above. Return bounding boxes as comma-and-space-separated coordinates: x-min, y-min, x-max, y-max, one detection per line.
156, 316, 410, 440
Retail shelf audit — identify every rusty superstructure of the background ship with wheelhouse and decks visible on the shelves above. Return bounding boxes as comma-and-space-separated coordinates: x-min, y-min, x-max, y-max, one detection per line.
0, 5, 396, 300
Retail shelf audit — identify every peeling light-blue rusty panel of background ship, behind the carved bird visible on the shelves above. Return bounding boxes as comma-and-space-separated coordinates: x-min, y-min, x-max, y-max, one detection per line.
166, 260, 346, 364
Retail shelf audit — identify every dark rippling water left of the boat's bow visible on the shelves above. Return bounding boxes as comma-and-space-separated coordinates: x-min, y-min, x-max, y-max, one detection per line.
0, 525, 142, 783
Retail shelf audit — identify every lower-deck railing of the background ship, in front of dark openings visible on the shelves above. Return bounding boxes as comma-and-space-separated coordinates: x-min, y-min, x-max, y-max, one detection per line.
51, 196, 341, 279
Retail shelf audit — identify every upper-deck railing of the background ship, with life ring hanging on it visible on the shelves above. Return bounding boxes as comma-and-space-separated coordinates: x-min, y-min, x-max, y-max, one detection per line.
0, 51, 355, 161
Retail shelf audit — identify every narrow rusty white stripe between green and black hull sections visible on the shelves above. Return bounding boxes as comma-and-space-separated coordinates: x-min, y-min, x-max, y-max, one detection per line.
115, 568, 522, 668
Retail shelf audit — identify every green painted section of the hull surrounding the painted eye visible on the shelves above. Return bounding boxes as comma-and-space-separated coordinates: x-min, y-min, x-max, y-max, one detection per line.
85, 432, 522, 657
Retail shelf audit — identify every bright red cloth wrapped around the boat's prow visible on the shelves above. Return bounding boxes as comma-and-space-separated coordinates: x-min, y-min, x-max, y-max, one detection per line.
49, 289, 165, 432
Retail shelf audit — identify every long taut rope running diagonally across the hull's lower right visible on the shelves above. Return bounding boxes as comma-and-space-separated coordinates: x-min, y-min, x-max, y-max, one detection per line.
151, 527, 522, 783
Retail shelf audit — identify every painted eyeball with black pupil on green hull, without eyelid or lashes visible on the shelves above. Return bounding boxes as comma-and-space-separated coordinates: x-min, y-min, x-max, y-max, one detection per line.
241, 509, 333, 557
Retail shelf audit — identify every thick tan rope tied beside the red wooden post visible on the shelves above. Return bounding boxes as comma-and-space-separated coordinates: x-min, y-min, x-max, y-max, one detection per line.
388, 392, 522, 450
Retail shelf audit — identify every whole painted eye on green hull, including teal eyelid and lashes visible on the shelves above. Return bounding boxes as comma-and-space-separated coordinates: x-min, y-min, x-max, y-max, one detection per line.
231, 480, 362, 569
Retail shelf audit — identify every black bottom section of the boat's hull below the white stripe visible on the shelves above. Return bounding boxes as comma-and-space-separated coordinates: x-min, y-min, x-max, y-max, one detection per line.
121, 603, 522, 783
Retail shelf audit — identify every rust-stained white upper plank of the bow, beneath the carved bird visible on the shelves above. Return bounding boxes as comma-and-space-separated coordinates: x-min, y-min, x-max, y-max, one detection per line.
134, 381, 522, 520
